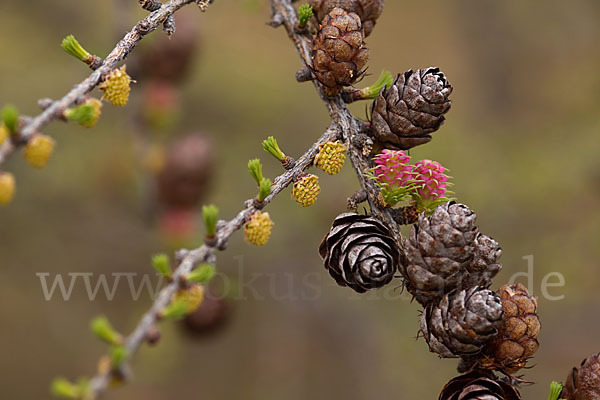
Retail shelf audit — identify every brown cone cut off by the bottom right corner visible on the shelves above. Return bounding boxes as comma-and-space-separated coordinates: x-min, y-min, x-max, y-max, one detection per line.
560, 354, 600, 400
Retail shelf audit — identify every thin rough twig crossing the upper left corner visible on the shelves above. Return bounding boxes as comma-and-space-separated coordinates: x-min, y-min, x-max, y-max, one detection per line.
0, 0, 199, 165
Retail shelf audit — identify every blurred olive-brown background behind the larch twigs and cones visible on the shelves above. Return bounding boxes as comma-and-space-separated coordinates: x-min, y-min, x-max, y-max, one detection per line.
0, 0, 600, 400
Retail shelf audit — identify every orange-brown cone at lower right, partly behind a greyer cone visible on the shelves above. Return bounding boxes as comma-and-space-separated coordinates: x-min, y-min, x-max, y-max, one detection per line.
479, 283, 541, 374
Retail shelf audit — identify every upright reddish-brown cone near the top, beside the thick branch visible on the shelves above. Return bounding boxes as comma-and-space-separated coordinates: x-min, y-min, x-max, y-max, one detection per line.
312, 7, 369, 96
